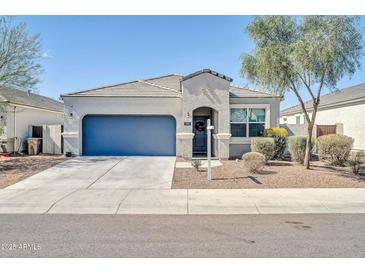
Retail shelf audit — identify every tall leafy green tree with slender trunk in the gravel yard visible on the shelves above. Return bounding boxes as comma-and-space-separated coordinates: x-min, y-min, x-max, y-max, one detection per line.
241, 16, 363, 168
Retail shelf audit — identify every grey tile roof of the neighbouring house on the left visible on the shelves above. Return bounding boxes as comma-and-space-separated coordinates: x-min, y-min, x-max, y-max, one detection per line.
0, 87, 64, 112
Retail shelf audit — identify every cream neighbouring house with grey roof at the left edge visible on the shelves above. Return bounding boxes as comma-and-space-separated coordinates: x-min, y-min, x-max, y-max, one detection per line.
0, 87, 64, 152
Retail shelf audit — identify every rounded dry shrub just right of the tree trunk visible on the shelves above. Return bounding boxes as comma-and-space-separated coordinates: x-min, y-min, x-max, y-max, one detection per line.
317, 134, 354, 166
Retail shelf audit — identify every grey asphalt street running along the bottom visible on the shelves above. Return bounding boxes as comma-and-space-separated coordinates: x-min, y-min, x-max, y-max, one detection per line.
0, 214, 365, 258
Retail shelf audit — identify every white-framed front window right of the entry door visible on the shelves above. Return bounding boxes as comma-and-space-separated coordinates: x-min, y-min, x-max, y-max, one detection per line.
231, 108, 266, 137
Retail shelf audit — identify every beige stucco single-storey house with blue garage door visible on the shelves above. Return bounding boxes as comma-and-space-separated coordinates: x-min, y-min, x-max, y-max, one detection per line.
61, 69, 280, 159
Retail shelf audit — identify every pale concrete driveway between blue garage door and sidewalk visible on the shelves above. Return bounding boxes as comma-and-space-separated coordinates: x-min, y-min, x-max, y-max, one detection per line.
7, 157, 175, 189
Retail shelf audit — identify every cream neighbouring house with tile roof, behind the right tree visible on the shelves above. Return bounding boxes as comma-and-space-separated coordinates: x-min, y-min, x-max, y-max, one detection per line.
280, 84, 365, 150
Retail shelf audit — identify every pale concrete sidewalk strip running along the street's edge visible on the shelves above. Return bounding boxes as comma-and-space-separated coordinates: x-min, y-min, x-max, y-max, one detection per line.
0, 188, 365, 215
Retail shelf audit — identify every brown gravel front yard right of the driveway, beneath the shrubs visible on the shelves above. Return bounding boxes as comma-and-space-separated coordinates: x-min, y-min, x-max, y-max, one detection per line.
172, 160, 365, 189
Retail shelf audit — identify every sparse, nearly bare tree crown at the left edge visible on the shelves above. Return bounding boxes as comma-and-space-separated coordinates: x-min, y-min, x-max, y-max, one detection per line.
0, 16, 42, 89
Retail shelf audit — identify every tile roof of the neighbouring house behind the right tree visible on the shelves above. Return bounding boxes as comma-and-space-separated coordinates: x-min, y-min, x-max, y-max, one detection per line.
280, 83, 365, 115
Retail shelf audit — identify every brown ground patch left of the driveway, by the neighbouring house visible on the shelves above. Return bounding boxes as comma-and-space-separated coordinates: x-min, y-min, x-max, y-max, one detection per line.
0, 155, 67, 188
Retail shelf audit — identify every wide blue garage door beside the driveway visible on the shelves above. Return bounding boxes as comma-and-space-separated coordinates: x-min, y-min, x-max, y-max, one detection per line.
82, 115, 176, 156
